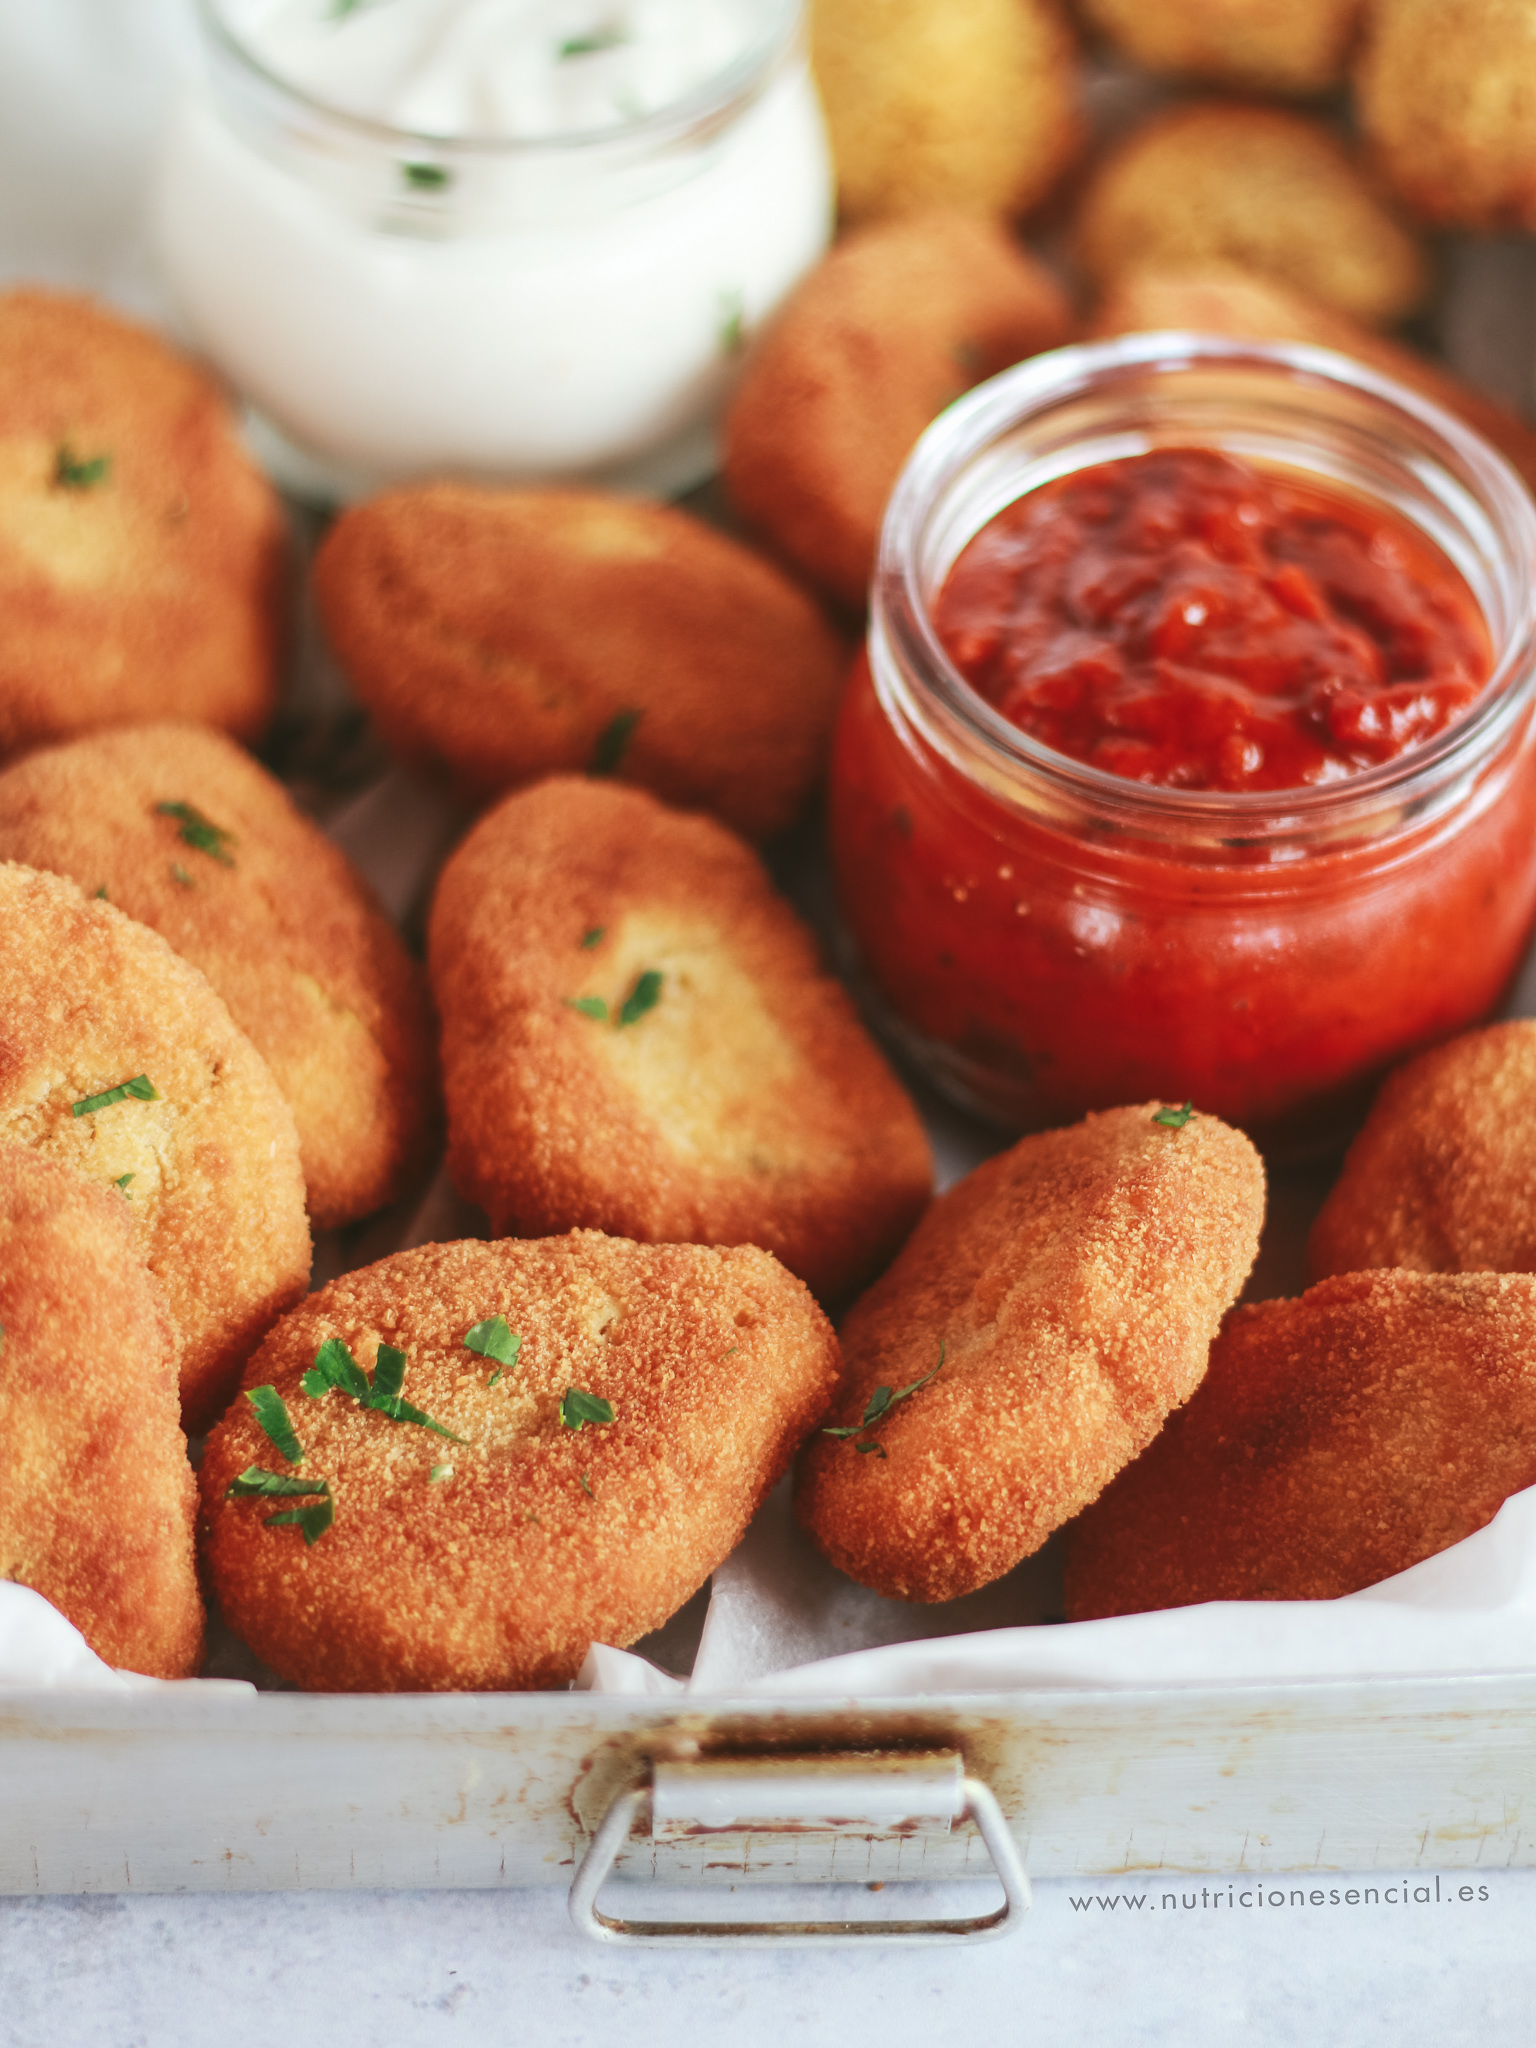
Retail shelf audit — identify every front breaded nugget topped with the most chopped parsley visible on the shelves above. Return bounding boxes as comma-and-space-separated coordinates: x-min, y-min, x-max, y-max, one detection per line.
201, 1231, 838, 1692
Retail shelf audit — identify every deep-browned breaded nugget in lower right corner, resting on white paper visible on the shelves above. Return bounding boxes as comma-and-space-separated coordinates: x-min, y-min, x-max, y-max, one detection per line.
1067, 1272, 1536, 1622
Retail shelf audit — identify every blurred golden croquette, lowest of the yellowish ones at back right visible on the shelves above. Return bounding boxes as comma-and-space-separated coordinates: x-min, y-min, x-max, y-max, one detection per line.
1075, 100, 1430, 324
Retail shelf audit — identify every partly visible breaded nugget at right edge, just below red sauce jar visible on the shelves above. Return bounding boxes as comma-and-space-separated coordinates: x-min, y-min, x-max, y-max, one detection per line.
1307, 1018, 1536, 1280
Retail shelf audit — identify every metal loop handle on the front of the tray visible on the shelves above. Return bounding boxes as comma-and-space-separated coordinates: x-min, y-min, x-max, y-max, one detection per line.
571, 1751, 1030, 1944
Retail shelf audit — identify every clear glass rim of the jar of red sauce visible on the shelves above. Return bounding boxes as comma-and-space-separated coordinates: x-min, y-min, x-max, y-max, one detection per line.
868, 330, 1536, 838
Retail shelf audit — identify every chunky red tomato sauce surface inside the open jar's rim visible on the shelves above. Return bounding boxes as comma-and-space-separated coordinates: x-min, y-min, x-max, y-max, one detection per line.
934, 449, 1491, 791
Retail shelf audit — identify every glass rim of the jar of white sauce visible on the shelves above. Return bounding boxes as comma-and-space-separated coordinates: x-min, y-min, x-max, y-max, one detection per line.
195, 0, 805, 162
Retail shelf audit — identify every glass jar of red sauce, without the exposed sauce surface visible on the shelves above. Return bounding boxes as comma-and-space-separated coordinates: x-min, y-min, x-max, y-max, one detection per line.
831, 334, 1536, 1157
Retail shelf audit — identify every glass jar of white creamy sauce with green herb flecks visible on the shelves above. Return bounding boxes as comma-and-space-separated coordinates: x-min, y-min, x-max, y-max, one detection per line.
154, 0, 831, 498
